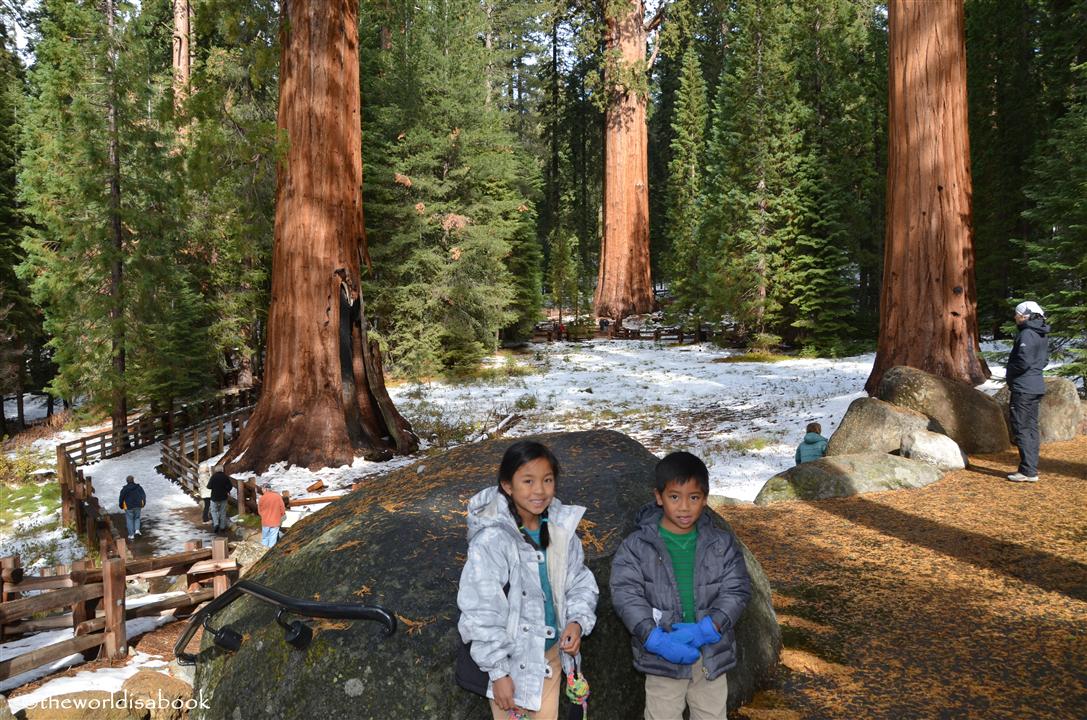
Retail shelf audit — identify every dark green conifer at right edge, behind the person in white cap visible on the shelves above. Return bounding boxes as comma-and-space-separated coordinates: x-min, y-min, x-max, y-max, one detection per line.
1013, 63, 1087, 385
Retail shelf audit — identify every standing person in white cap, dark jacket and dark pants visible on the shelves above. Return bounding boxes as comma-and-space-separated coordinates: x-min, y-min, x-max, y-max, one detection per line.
1004, 300, 1049, 483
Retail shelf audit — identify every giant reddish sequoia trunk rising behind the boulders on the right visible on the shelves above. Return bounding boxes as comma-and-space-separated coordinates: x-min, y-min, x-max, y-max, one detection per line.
865, 0, 989, 394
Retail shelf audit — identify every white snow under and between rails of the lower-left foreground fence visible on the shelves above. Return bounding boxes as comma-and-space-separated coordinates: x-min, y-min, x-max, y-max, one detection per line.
0, 593, 183, 700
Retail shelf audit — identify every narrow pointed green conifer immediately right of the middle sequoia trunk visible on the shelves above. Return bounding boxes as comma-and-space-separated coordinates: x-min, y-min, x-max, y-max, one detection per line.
667, 45, 709, 327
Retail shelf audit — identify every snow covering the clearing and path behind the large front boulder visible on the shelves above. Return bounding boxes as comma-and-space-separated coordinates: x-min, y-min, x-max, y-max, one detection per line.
8, 340, 1026, 565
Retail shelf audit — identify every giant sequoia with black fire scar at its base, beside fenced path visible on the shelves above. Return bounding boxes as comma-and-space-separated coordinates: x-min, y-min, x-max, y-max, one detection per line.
226, 0, 417, 471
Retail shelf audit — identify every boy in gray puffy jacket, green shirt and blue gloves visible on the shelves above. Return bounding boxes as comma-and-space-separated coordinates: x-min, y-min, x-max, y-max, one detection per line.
611, 452, 751, 720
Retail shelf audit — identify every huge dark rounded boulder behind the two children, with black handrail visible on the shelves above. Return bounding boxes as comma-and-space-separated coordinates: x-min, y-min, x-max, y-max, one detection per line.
191, 432, 780, 720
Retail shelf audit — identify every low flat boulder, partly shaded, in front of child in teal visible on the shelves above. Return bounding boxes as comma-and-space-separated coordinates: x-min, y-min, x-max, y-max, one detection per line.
754, 452, 944, 505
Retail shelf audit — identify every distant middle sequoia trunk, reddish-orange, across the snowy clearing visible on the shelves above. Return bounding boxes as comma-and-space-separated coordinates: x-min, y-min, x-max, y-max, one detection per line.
594, 0, 653, 321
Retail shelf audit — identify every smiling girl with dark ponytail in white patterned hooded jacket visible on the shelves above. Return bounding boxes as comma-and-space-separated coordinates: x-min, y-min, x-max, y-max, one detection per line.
457, 440, 599, 720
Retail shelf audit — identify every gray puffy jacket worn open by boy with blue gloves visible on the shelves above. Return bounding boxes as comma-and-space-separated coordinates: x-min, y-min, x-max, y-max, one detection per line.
611, 502, 751, 680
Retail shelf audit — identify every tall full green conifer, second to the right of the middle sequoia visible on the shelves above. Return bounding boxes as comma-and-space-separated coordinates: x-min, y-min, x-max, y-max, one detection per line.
701, 0, 804, 344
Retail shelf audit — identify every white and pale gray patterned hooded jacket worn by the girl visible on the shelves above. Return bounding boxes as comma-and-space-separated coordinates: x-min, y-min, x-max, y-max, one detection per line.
457, 487, 600, 710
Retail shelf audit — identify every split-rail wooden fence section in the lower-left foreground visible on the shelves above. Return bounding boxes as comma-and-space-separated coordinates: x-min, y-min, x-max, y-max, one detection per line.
0, 537, 238, 680
